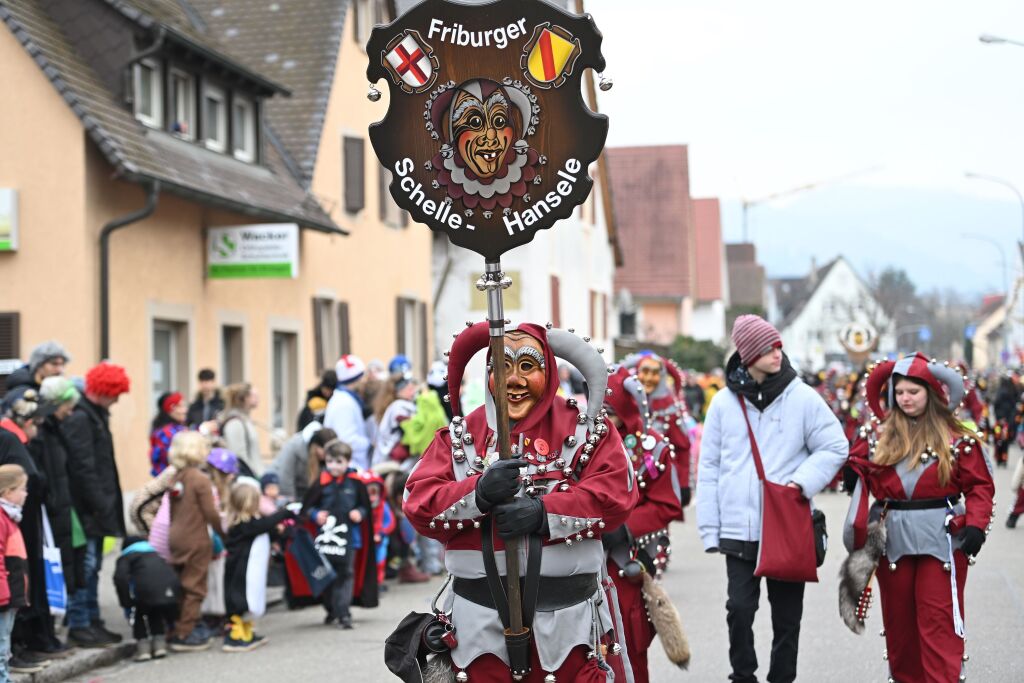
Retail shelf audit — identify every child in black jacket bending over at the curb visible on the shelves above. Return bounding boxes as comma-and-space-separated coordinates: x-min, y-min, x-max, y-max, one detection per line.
114, 536, 181, 661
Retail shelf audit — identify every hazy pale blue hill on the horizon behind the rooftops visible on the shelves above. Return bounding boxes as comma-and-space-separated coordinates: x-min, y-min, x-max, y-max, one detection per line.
722, 185, 1022, 294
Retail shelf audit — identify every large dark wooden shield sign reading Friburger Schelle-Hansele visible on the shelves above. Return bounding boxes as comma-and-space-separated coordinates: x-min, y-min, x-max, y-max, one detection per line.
367, 0, 608, 260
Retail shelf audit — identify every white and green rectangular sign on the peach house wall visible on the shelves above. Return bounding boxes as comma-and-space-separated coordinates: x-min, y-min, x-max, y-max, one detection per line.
207, 223, 299, 280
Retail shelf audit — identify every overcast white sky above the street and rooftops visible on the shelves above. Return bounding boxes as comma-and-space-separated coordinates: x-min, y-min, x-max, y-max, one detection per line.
586, 0, 1024, 293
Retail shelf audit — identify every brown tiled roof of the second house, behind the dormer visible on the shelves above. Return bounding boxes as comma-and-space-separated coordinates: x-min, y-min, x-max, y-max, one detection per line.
189, 0, 352, 186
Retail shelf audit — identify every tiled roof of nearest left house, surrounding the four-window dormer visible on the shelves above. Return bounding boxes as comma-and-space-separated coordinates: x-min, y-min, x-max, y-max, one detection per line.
0, 0, 339, 231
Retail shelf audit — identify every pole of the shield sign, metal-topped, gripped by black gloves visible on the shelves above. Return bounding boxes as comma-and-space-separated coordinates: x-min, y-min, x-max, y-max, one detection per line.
483, 260, 523, 635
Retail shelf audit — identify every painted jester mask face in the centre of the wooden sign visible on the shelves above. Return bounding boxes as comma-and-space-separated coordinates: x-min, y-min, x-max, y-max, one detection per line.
452, 89, 518, 179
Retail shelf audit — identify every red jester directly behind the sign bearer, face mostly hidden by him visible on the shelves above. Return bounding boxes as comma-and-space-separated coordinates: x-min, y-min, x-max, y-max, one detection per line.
603, 368, 683, 683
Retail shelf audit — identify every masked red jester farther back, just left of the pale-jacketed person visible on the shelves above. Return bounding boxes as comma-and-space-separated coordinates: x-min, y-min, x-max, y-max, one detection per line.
624, 351, 690, 509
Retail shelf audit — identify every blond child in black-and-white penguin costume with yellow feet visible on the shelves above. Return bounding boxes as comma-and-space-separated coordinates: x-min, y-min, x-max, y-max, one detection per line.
222, 479, 294, 652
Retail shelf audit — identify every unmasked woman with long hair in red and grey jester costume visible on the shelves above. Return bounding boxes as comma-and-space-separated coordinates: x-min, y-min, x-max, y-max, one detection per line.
844, 353, 995, 683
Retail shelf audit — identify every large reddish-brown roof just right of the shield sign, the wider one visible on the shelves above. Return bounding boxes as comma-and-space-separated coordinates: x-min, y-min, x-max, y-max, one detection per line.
605, 145, 695, 299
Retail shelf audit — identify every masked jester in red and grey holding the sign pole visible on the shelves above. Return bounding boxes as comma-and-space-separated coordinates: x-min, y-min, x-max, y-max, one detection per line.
402, 324, 636, 683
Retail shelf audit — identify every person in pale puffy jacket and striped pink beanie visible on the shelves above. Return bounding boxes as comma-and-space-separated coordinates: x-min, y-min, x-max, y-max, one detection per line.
696, 315, 849, 683
